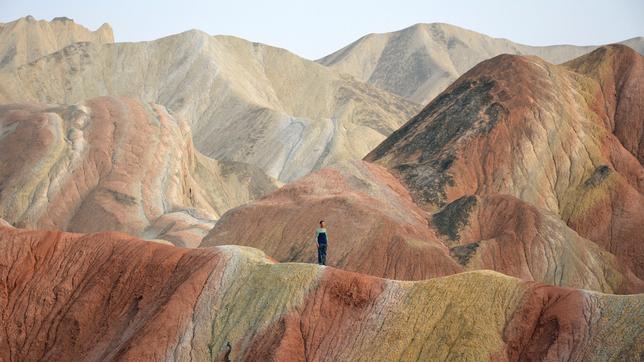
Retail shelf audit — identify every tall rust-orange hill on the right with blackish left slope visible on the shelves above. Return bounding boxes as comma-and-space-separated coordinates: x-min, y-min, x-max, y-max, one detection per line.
366, 46, 644, 278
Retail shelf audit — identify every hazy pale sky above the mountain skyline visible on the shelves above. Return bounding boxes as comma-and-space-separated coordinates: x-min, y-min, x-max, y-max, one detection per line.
0, 0, 644, 59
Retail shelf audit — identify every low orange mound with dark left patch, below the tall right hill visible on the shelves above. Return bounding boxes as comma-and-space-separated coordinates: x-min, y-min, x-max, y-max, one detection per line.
431, 195, 644, 293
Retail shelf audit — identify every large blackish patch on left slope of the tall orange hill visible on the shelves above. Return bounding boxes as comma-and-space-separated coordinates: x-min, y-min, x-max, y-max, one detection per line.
367, 78, 508, 207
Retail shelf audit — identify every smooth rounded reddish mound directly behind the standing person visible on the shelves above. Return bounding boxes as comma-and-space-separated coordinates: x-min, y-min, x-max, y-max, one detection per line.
201, 161, 462, 280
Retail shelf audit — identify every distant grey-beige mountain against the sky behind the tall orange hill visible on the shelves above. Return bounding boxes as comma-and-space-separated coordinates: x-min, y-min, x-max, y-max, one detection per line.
318, 23, 644, 104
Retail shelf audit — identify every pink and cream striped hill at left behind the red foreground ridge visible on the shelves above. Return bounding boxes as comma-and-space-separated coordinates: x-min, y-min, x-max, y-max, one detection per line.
0, 97, 276, 246
